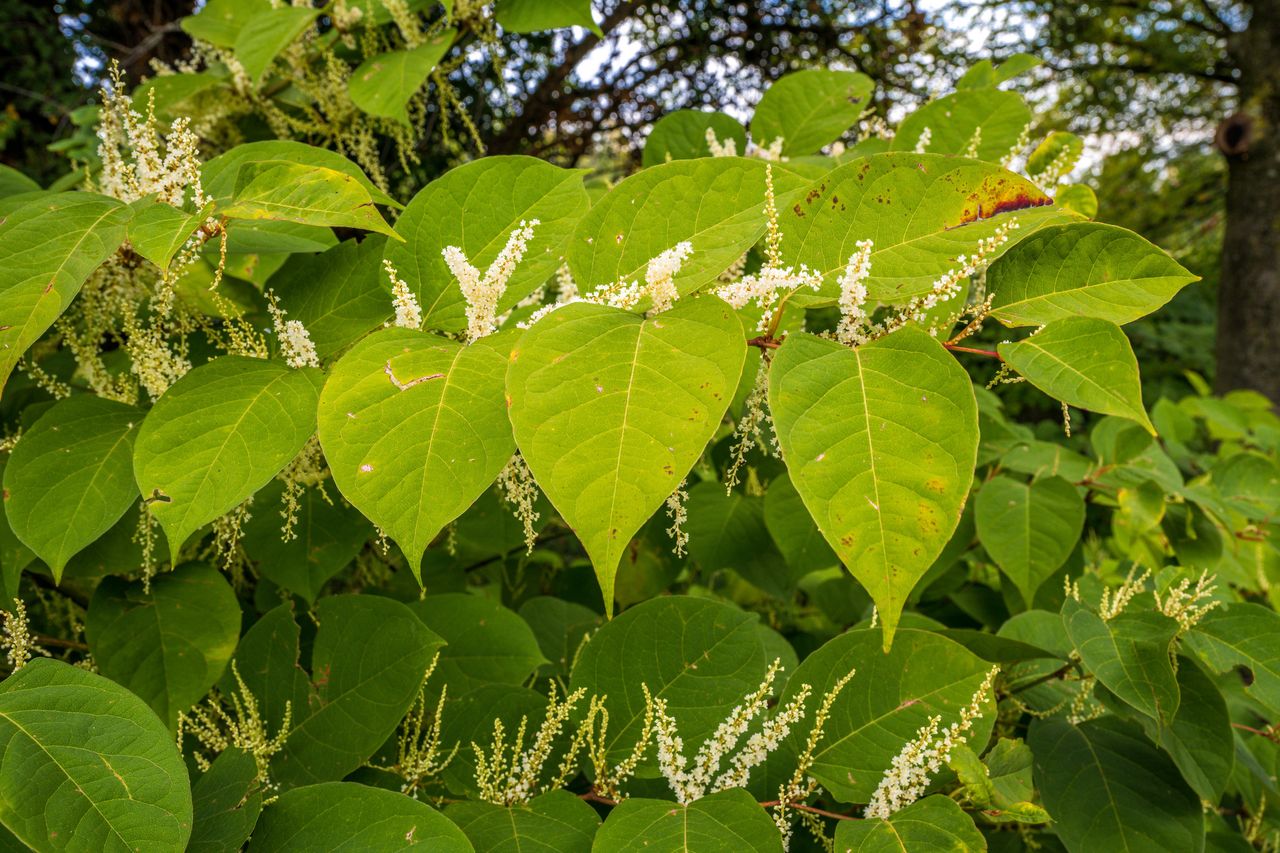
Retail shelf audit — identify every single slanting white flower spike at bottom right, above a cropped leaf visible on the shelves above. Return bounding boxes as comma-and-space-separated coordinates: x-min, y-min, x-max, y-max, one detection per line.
863, 666, 1000, 818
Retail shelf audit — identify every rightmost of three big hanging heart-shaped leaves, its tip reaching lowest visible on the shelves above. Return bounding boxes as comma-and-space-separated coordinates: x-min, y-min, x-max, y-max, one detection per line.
769, 327, 978, 648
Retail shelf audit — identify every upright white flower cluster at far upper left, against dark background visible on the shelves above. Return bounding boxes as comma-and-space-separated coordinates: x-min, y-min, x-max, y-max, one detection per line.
97, 69, 209, 209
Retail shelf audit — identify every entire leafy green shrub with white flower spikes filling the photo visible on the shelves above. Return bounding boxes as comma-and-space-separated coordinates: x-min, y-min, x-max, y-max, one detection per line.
0, 6, 1280, 853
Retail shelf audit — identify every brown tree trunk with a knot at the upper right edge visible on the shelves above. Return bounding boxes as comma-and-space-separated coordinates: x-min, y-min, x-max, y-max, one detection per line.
1216, 0, 1280, 406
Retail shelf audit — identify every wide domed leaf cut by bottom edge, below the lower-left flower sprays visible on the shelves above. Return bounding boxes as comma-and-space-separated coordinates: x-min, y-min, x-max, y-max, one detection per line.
248, 783, 472, 853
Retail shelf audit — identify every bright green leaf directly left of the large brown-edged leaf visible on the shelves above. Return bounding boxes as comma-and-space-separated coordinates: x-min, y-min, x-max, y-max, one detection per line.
568, 158, 808, 302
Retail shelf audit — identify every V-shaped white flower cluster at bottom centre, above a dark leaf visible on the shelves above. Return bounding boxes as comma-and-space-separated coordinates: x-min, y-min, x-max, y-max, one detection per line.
645, 660, 812, 803
